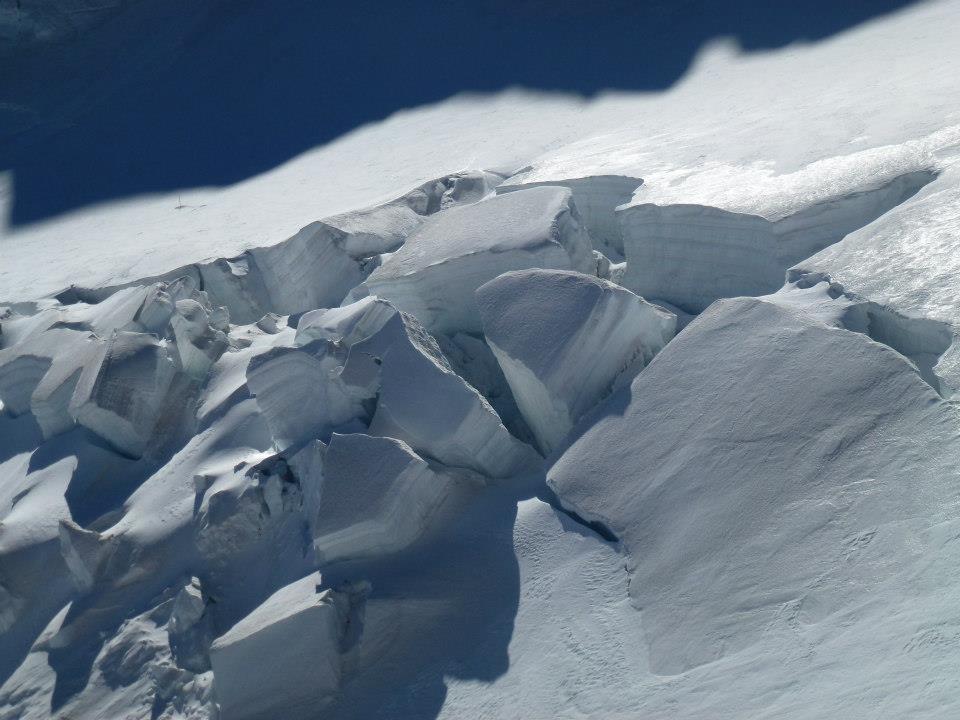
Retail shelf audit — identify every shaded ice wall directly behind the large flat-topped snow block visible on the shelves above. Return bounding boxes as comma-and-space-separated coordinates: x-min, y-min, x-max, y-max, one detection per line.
496, 173, 643, 261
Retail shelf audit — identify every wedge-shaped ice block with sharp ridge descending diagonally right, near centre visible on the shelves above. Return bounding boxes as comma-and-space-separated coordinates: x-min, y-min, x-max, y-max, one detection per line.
288, 296, 540, 477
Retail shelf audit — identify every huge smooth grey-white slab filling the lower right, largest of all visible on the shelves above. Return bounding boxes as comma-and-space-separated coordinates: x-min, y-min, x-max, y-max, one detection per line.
548, 299, 960, 688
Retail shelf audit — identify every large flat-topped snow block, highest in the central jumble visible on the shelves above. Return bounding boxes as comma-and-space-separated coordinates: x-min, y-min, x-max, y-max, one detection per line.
362, 187, 595, 333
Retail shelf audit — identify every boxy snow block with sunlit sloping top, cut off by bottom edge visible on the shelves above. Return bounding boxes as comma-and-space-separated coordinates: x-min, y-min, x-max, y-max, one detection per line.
210, 573, 349, 720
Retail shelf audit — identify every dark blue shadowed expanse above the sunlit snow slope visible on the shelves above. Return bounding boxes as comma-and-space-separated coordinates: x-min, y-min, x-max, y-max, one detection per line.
0, 0, 911, 225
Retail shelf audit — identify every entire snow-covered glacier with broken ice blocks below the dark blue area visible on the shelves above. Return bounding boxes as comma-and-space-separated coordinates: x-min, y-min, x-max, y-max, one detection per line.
0, 0, 960, 720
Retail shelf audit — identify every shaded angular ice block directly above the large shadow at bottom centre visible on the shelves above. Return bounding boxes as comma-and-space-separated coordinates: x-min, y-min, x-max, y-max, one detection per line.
313, 433, 453, 565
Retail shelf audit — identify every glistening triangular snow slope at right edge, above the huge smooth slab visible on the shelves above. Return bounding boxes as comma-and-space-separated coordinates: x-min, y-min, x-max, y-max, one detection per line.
789, 153, 960, 397
